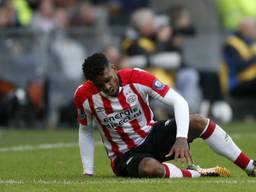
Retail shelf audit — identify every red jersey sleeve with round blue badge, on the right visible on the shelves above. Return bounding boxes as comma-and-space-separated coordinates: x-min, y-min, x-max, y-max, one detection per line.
133, 68, 170, 97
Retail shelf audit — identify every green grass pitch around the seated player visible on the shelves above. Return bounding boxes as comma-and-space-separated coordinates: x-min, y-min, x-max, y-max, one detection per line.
0, 123, 256, 192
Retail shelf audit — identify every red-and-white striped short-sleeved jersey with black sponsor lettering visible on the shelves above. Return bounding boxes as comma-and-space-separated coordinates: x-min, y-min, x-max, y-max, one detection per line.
74, 69, 169, 160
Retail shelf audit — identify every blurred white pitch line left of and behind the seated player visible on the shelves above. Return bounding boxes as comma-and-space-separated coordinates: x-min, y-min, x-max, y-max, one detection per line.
0, 142, 102, 152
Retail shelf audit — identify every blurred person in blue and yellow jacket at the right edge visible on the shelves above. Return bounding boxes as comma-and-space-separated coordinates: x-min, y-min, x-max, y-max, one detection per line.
223, 18, 256, 98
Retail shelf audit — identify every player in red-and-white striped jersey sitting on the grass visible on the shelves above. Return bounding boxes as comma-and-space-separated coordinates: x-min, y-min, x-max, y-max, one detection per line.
74, 53, 256, 178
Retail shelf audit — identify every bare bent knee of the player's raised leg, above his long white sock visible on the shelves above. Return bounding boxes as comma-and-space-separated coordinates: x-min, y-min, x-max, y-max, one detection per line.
189, 114, 207, 139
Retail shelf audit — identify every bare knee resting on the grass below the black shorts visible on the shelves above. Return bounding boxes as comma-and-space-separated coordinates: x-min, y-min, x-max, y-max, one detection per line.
139, 157, 164, 177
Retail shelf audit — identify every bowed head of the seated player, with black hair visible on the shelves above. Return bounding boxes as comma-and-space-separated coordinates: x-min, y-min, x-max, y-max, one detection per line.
83, 53, 119, 96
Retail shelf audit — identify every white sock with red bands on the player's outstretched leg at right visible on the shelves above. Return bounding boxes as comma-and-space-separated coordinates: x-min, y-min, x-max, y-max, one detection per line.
200, 120, 254, 172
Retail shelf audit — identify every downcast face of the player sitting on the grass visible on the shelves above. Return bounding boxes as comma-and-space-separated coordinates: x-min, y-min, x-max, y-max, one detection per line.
94, 67, 119, 97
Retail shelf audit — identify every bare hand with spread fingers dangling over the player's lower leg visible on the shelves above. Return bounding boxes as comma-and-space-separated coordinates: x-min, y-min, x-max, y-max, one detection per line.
165, 137, 193, 165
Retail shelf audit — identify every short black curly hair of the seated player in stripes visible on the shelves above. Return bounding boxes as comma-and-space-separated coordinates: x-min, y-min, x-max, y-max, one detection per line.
83, 53, 109, 81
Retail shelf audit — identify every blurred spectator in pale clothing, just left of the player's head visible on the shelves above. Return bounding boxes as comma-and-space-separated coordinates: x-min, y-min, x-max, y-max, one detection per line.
49, 8, 87, 126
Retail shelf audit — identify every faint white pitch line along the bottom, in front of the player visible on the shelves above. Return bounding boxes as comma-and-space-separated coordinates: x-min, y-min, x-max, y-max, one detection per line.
0, 178, 256, 185
